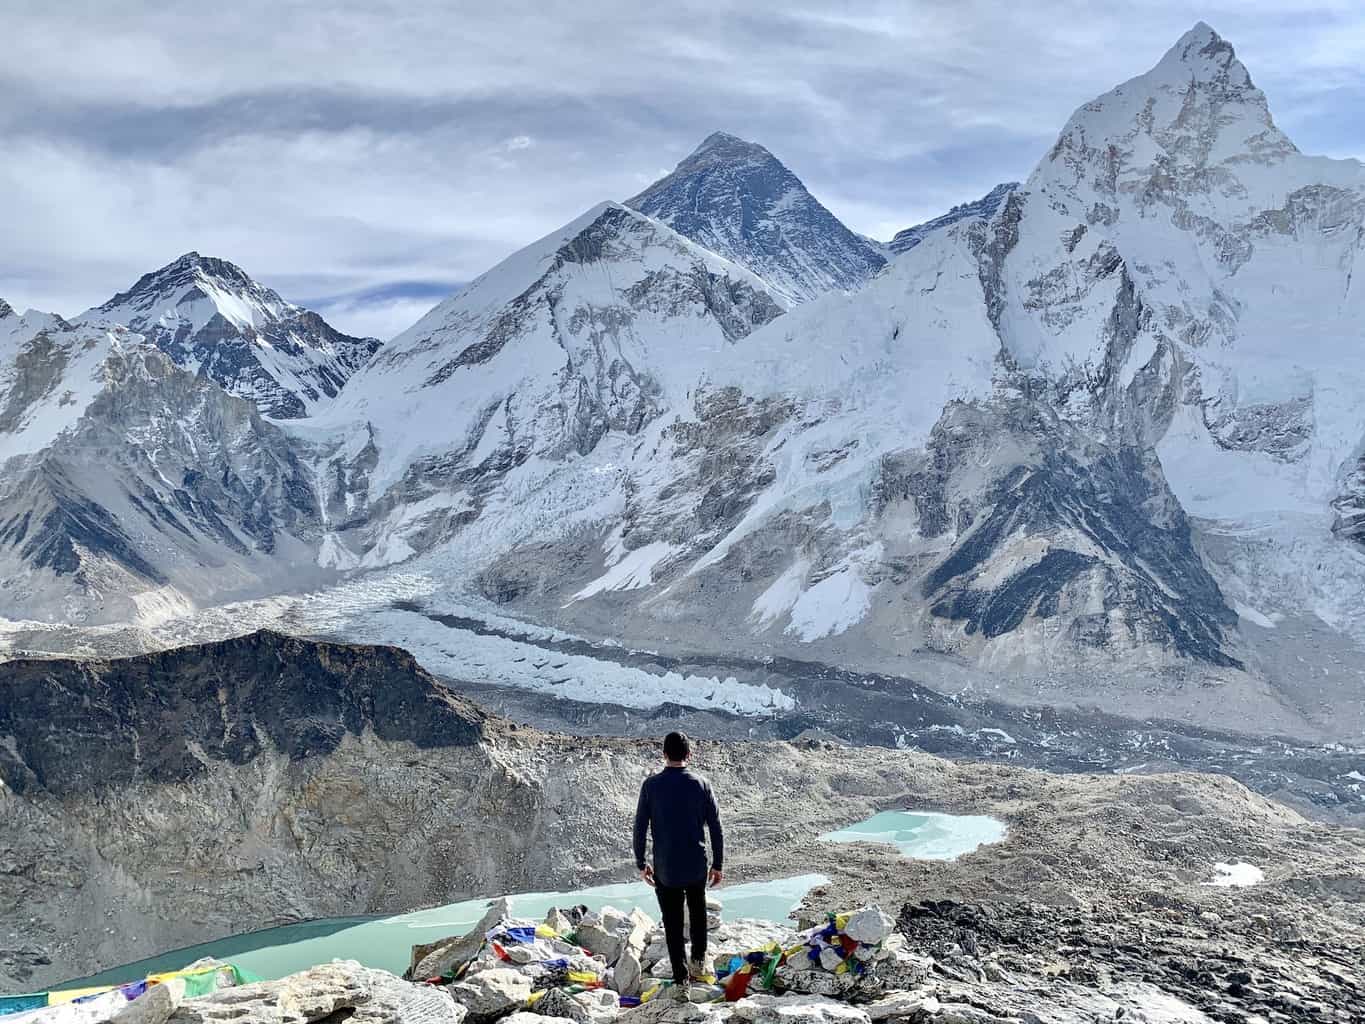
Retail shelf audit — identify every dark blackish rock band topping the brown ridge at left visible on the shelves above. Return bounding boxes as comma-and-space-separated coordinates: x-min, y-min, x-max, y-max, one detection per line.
0, 631, 486, 797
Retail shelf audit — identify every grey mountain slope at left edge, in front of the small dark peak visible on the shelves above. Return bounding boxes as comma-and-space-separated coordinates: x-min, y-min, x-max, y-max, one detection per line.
0, 313, 326, 623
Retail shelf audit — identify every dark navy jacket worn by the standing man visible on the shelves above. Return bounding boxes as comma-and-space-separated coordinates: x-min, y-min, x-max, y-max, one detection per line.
635, 766, 725, 887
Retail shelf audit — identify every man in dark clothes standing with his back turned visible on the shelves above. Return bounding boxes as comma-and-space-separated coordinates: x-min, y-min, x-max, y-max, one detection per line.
635, 732, 725, 986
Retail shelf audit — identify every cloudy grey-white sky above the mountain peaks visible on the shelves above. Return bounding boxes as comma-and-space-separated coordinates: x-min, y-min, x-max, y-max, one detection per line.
0, 0, 1365, 337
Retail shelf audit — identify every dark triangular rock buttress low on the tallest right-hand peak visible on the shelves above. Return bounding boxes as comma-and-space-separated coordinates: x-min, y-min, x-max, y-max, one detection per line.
879, 401, 1241, 668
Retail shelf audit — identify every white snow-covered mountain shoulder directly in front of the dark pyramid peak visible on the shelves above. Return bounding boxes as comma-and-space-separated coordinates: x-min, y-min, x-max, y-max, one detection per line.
307, 203, 782, 568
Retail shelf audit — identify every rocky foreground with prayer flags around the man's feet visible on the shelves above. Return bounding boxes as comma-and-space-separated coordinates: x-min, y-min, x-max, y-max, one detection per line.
20, 901, 1365, 1024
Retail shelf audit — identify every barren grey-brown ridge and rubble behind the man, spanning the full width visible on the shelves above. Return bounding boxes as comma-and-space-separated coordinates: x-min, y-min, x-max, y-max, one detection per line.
0, 632, 1365, 1021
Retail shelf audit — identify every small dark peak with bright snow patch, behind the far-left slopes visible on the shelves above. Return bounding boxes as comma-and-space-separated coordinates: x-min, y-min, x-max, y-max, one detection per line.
76, 253, 379, 419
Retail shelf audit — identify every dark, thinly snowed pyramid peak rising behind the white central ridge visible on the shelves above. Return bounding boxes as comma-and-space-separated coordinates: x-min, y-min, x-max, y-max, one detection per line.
627, 131, 886, 302
